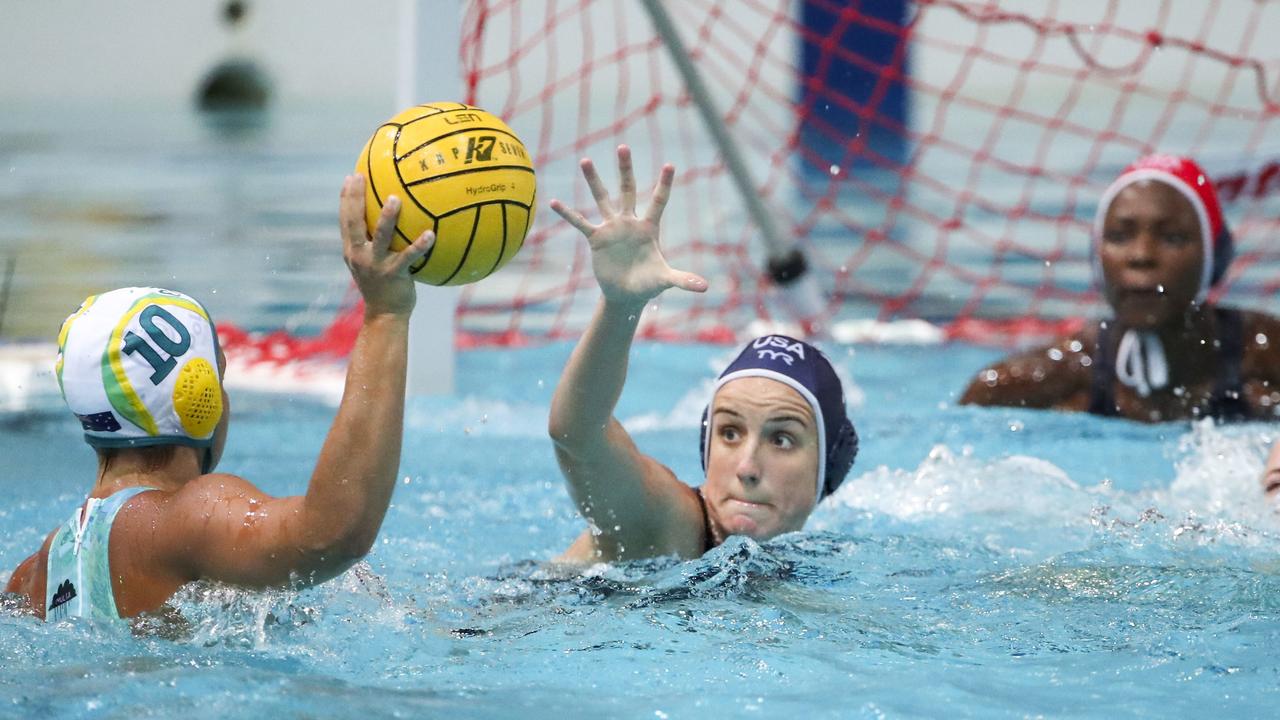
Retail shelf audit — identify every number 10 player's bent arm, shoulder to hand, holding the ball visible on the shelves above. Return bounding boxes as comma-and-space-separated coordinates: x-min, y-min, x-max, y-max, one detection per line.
151, 176, 433, 587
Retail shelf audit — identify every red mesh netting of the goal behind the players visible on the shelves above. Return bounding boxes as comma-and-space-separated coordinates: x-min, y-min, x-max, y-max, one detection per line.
230, 0, 1280, 358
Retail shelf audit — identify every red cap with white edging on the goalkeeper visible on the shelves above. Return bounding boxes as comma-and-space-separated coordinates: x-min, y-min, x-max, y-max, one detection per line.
1093, 155, 1235, 304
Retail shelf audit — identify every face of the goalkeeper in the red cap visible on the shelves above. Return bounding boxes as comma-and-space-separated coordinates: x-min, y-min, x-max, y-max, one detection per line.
1098, 181, 1204, 328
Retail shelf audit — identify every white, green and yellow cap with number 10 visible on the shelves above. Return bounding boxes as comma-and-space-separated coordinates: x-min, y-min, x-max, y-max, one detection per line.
55, 287, 223, 447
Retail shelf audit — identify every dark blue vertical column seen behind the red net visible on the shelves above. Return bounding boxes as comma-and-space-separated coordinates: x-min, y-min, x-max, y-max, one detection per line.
797, 0, 910, 174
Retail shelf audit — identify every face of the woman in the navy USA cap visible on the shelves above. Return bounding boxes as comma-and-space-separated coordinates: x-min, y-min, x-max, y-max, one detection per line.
703, 378, 818, 539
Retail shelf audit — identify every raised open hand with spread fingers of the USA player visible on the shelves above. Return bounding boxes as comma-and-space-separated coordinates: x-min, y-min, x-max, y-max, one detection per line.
550, 145, 707, 305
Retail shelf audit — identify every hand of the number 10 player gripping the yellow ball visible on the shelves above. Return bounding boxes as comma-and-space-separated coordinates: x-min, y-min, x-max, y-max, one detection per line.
338, 174, 435, 314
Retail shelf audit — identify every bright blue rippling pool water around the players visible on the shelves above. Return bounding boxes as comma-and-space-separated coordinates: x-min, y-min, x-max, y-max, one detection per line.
0, 345, 1280, 719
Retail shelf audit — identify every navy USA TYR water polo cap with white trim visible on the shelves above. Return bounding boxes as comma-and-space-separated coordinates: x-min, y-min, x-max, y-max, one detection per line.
699, 334, 858, 500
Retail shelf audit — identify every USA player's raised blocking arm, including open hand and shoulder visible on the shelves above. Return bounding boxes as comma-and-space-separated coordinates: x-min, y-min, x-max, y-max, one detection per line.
548, 146, 707, 560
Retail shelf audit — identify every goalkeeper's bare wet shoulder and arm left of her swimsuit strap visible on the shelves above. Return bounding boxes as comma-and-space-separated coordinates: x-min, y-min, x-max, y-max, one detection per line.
960, 338, 1093, 411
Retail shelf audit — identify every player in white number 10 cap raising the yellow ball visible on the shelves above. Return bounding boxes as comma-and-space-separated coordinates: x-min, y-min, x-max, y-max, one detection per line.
5, 176, 434, 620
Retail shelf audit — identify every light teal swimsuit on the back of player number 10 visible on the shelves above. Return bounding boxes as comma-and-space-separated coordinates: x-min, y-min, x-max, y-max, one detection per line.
45, 487, 156, 621
